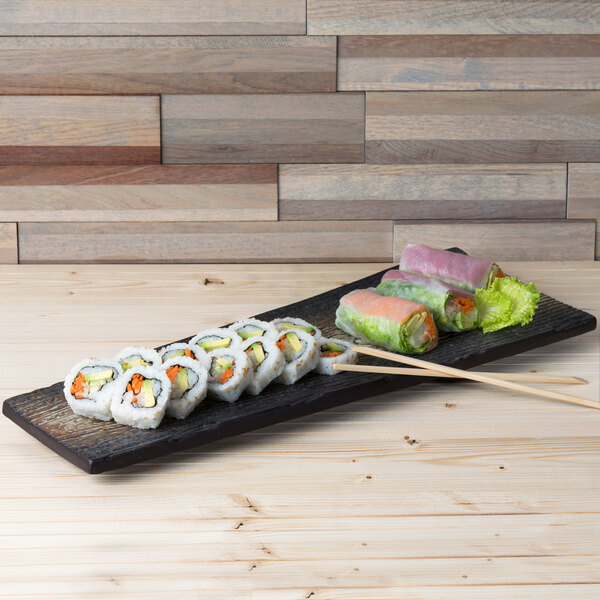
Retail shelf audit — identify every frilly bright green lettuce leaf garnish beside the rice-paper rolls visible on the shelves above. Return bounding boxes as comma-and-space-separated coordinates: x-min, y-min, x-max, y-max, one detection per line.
475, 277, 540, 333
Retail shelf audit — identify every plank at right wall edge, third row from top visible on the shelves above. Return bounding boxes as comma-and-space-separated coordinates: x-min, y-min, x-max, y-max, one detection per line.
366, 91, 600, 163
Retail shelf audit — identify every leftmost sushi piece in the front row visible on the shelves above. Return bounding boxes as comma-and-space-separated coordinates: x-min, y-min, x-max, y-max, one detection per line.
64, 358, 123, 421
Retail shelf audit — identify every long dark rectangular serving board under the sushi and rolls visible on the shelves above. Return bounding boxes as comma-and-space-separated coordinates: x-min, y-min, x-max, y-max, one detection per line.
2, 249, 596, 473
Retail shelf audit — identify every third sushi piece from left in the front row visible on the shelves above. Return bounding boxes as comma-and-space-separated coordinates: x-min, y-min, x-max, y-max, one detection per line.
162, 356, 208, 419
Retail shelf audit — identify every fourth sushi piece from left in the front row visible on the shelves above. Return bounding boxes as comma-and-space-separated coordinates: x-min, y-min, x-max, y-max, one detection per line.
208, 348, 252, 402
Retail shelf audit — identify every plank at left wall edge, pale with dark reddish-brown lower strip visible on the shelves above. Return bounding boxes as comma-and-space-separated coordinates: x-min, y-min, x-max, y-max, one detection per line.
0, 96, 160, 165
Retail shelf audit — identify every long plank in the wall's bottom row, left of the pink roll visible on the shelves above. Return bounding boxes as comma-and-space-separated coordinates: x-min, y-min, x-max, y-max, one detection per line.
19, 221, 392, 263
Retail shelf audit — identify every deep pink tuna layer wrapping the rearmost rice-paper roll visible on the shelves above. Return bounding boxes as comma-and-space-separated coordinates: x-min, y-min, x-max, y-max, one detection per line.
400, 244, 494, 291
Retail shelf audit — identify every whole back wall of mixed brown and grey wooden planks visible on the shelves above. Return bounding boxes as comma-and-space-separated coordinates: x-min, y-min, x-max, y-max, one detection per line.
0, 0, 600, 263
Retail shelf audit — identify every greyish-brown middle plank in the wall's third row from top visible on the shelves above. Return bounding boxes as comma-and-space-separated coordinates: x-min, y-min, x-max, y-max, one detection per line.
162, 94, 364, 163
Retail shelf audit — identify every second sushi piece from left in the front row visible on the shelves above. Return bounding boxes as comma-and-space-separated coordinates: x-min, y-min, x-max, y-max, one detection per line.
110, 366, 171, 429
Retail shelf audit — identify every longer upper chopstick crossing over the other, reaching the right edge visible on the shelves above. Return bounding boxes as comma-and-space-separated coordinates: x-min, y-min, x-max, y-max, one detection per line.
352, 346, 600, 410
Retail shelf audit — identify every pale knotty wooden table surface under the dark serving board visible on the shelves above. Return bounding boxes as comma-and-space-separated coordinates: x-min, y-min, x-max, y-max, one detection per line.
0, 262, 600, 600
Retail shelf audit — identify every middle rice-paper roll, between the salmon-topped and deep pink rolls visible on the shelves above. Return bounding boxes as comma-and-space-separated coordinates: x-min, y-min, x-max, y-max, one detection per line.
375, 269, 478, 332
